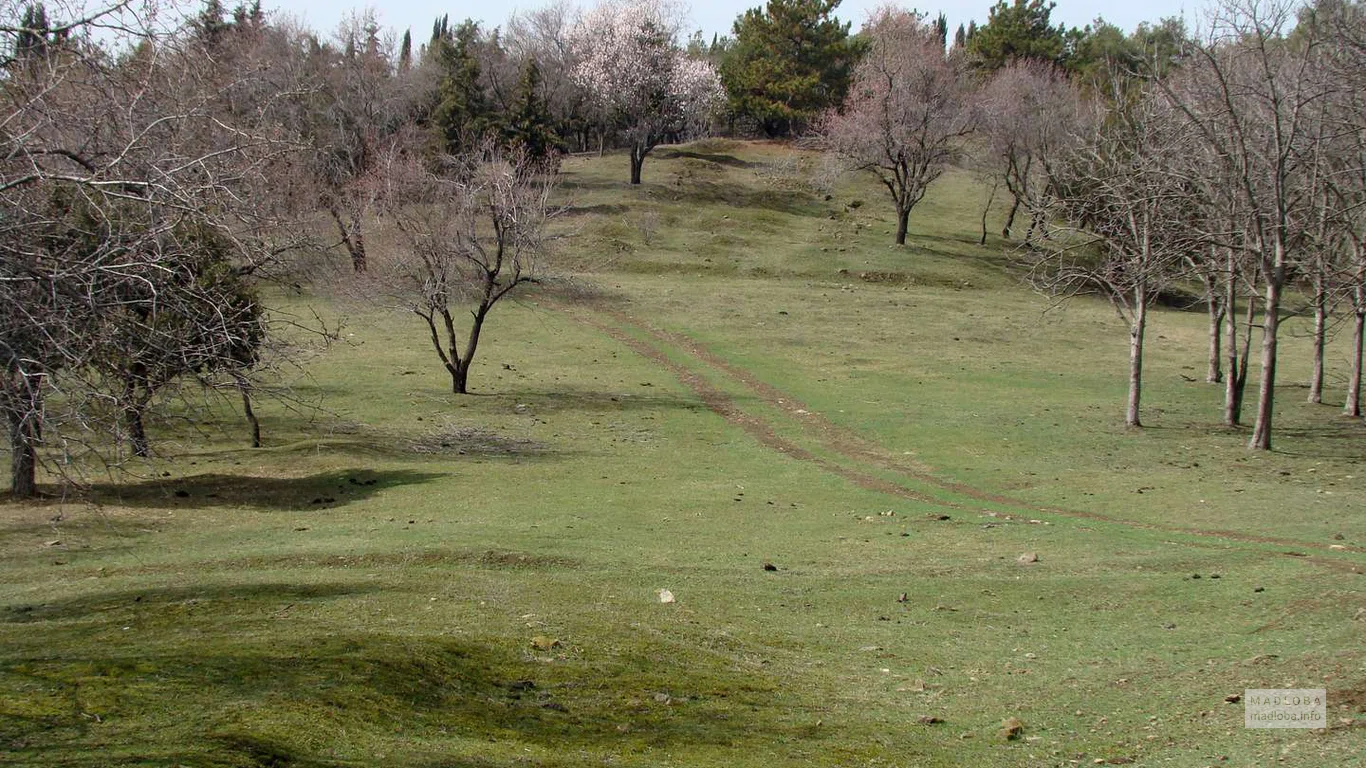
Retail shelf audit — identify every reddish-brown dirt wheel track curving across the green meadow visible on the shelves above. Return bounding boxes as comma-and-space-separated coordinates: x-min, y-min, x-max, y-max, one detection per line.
549, 305, 1366, 573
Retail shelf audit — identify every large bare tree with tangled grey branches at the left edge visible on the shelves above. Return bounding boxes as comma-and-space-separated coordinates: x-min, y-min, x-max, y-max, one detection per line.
0, 4, 304, 497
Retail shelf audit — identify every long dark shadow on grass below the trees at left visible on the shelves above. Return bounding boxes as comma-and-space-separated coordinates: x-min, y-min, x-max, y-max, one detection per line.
89, 469, 441, 511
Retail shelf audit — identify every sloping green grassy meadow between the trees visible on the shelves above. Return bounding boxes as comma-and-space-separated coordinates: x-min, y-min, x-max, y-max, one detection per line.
0, 142, 1366, 768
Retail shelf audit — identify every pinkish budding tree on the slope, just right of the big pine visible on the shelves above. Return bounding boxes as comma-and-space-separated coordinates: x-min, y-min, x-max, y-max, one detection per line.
821, 8, 975, 245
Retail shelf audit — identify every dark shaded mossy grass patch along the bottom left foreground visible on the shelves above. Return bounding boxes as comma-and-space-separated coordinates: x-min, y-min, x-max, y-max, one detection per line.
0, 630, 818, 768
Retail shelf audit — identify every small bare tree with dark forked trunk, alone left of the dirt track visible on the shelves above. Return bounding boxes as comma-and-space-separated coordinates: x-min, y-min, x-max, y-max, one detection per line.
366, 143, 557, 395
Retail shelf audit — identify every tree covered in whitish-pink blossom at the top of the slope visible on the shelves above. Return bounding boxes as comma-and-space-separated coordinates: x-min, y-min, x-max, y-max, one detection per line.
570, 0, 725, 184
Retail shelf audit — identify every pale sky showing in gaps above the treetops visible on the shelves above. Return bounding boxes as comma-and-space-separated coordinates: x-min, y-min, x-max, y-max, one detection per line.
263, 0, 1203, 44
